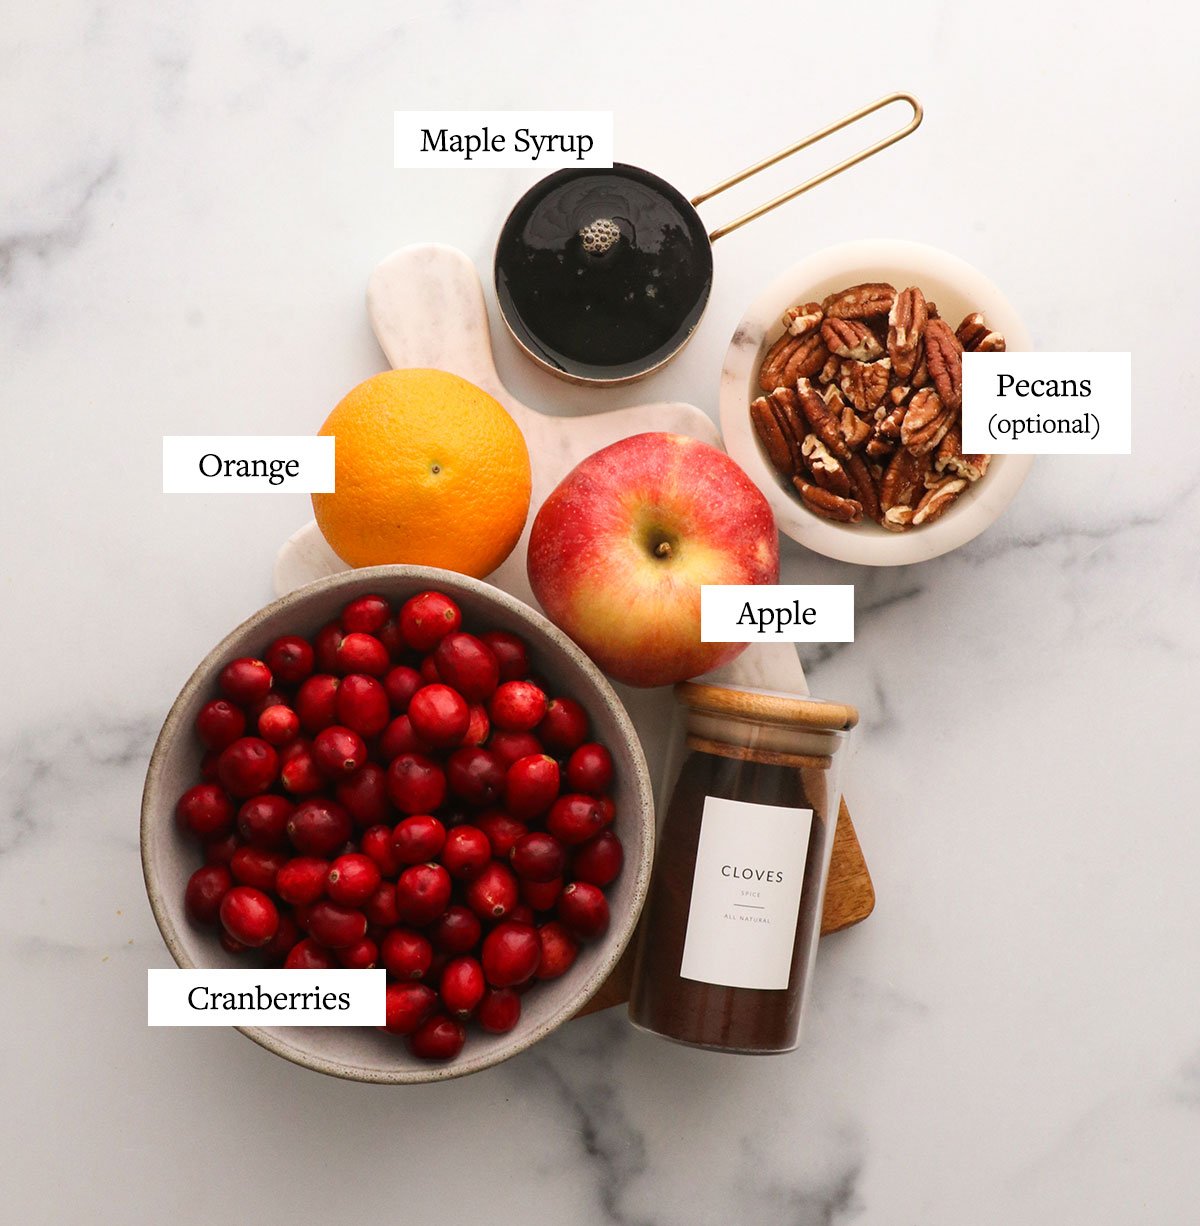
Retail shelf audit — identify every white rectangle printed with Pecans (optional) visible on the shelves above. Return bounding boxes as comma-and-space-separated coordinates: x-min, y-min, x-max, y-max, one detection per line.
962, 353, 1133, 456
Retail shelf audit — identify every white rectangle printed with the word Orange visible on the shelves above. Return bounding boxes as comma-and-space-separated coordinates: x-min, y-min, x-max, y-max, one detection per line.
163, 434, 335, 494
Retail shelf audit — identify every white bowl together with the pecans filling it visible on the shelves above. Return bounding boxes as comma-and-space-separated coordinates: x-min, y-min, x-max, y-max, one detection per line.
721, 239, 1032, 566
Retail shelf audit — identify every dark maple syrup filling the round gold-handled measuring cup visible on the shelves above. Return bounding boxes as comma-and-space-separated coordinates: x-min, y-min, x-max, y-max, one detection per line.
495, 164, 712, 379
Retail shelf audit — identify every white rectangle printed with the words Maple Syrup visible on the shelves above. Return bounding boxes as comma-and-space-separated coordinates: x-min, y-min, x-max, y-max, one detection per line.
392, 110, 613, 170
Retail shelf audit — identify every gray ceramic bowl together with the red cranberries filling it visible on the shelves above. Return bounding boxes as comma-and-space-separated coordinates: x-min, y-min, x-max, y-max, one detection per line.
141, 566, 653, 1083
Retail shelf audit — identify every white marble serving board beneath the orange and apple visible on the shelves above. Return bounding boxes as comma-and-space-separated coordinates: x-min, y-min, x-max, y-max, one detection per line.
275, 243, 808, 715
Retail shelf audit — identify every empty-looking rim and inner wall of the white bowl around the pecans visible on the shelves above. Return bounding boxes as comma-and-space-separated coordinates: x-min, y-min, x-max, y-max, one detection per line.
721, 239, 1033, 566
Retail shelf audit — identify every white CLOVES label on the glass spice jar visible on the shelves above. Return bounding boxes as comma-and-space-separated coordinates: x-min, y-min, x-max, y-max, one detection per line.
679, 796, 813, 989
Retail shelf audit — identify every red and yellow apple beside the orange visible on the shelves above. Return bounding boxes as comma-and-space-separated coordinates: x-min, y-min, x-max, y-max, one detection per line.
528, 433, 780, 685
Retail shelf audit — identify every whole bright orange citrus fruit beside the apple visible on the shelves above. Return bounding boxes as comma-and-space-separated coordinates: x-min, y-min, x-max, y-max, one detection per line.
313, 370, 530, 579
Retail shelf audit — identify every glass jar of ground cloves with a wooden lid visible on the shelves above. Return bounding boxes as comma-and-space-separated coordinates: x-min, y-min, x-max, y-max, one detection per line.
629, 682, 858, 1054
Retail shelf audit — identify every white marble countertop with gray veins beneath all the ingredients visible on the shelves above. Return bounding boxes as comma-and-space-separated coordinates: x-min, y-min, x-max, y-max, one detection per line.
0, 0, 1200, 1226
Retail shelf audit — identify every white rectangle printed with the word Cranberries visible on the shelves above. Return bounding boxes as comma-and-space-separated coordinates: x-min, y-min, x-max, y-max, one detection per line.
146, 966, 387, 1026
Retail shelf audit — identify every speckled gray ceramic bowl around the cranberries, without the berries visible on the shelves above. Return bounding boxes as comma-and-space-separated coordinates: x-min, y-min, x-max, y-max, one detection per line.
141, 566, 655, 1083
